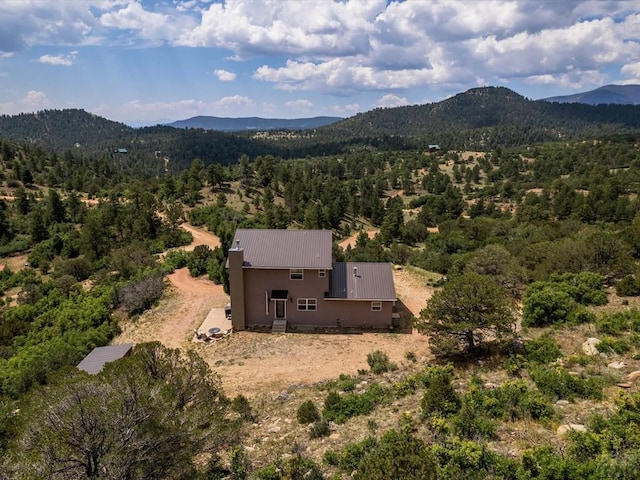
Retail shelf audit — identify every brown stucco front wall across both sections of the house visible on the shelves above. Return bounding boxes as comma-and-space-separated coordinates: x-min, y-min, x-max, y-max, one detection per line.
243, 268, 393, 328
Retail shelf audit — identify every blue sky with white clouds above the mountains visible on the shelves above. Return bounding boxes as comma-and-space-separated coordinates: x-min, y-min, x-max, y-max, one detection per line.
0, 0, 640, 126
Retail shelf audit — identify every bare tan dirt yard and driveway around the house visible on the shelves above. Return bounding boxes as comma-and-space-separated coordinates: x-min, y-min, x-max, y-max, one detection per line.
114, 225, 432, 397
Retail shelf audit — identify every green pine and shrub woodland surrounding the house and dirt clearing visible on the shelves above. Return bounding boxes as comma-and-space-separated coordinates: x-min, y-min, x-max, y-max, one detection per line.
0, 93, 640, 480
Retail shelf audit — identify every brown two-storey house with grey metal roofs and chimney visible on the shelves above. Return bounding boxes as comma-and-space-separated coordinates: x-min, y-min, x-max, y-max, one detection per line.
228, 229, 396, 331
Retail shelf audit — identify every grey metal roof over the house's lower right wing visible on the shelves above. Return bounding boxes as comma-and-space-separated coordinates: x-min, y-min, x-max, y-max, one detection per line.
330, 262, 396, 301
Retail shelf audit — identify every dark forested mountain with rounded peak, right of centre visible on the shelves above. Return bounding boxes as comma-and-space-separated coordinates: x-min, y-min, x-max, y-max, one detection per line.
320, 87, 640, 149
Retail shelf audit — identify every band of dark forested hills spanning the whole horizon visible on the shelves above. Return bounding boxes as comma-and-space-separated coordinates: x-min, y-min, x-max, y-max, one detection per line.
0, 87, 640, 171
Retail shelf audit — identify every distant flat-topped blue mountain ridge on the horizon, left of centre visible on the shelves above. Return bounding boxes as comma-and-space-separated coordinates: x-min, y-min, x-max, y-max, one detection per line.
167, 116, 342, 132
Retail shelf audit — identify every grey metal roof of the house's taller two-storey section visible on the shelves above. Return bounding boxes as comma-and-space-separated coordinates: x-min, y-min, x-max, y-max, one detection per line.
231, 228, 332, 270
